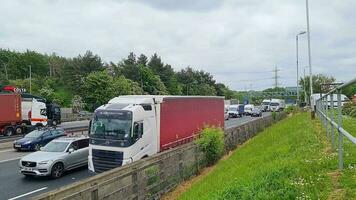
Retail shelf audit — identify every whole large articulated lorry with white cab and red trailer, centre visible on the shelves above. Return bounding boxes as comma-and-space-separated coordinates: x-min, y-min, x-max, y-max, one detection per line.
88, 95, 224, 173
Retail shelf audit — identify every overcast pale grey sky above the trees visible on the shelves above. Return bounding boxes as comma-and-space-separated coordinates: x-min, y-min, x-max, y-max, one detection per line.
0, 0, 356, 90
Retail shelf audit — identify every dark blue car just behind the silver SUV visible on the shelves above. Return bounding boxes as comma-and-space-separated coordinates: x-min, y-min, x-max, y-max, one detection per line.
13, 128, 66, 151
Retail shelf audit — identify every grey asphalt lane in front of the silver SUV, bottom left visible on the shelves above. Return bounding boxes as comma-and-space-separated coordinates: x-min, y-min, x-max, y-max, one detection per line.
0, 160, 93, 199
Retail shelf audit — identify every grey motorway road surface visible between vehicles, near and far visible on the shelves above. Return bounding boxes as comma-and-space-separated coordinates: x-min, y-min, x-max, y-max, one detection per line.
0, 113, 270, 200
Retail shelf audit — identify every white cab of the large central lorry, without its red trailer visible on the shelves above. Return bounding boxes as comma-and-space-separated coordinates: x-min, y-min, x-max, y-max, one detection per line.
88, 96, 159, 172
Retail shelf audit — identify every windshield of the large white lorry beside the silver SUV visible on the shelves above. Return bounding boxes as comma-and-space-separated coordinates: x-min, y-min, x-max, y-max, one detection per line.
90, 111, 132, 141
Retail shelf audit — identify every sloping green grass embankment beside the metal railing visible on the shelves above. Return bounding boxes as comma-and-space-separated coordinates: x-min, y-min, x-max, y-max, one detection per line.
177, 113, 356, 199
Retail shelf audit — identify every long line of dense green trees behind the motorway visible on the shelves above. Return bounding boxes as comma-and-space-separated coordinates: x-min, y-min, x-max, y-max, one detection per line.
0, 49, 234, 110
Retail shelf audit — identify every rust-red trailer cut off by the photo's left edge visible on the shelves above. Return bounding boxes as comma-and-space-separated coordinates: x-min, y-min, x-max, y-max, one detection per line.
0, 94, 23, 135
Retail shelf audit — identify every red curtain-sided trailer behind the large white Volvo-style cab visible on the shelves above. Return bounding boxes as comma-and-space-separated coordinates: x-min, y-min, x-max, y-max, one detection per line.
159, 96, 225, 151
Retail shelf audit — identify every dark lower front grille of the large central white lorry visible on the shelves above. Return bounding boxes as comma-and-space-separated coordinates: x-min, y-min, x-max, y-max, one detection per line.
92, 149, 124, 173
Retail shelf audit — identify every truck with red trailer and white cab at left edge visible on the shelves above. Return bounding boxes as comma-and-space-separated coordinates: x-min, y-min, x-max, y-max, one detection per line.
0, 93, 57, 136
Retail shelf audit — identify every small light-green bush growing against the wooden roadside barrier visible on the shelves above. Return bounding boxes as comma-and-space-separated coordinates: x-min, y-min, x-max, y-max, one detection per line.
196, 127, 224, 165
